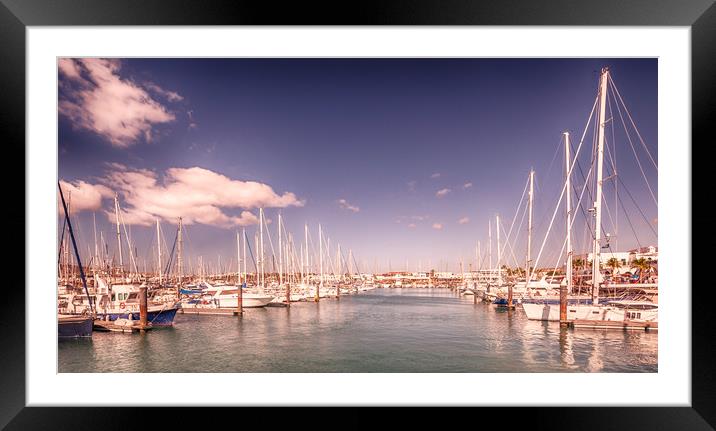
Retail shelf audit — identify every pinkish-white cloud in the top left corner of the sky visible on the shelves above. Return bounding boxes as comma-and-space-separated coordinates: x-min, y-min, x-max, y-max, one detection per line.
58, 58, 176, 148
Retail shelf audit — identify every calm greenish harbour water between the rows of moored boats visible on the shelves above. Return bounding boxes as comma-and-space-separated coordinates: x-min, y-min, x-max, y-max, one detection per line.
58, 288, 658, 373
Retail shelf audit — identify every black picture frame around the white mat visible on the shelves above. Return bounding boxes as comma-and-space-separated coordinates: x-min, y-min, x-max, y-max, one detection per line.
0, 0, 716, 430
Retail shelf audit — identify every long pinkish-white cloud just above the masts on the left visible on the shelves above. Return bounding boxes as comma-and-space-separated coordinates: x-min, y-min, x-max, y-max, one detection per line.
61, 163, 304, 228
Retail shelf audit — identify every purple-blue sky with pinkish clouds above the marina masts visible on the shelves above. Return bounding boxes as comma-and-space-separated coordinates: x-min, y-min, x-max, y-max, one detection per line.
58, 58, 658, 272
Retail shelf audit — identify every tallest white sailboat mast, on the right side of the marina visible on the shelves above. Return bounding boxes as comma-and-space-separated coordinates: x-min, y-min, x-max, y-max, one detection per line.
592, 68, 609, 305
